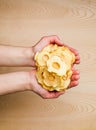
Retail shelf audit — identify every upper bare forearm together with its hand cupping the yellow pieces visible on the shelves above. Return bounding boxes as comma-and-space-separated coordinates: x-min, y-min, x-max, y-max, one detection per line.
0, 36, 80, 67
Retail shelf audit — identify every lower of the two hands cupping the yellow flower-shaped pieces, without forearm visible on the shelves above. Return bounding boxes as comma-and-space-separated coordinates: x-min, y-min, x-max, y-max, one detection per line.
28, 69, 79, 99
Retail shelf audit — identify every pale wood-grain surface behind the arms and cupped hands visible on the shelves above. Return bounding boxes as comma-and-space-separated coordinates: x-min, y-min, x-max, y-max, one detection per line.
0, 0, 96, 130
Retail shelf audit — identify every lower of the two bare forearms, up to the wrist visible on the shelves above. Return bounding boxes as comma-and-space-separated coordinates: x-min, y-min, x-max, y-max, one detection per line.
0, 71, 30, 95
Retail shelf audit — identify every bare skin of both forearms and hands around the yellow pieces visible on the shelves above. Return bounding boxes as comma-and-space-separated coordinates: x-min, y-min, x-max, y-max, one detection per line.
0, 35, 80, 98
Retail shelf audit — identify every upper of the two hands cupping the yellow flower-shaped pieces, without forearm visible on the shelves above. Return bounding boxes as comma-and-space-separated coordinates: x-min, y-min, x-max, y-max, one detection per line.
32, 35, 80, 67
